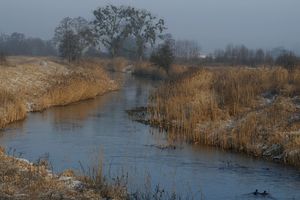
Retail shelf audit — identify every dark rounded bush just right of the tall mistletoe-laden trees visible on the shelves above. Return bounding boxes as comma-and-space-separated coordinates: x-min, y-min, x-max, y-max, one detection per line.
150, 41, 174, 73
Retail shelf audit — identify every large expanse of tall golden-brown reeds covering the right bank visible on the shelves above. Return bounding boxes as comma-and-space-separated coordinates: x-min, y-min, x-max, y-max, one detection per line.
149, 67, 300, 166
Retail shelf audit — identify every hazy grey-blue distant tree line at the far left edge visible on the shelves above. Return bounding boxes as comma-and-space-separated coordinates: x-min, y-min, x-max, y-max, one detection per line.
0, 33, 57, 56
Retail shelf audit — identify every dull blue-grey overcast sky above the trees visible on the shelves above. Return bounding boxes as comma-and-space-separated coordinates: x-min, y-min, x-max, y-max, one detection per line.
0, 0, 300, 52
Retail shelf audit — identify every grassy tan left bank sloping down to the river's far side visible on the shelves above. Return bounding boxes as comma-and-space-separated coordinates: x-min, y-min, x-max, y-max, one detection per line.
0, 57, 118, 128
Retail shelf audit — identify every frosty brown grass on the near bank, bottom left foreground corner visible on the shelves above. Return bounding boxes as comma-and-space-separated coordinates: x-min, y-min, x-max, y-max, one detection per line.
0, 148, 127, 200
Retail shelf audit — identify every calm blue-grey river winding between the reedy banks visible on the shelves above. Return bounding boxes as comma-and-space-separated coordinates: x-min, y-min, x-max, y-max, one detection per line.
0, 75, 300, 199
